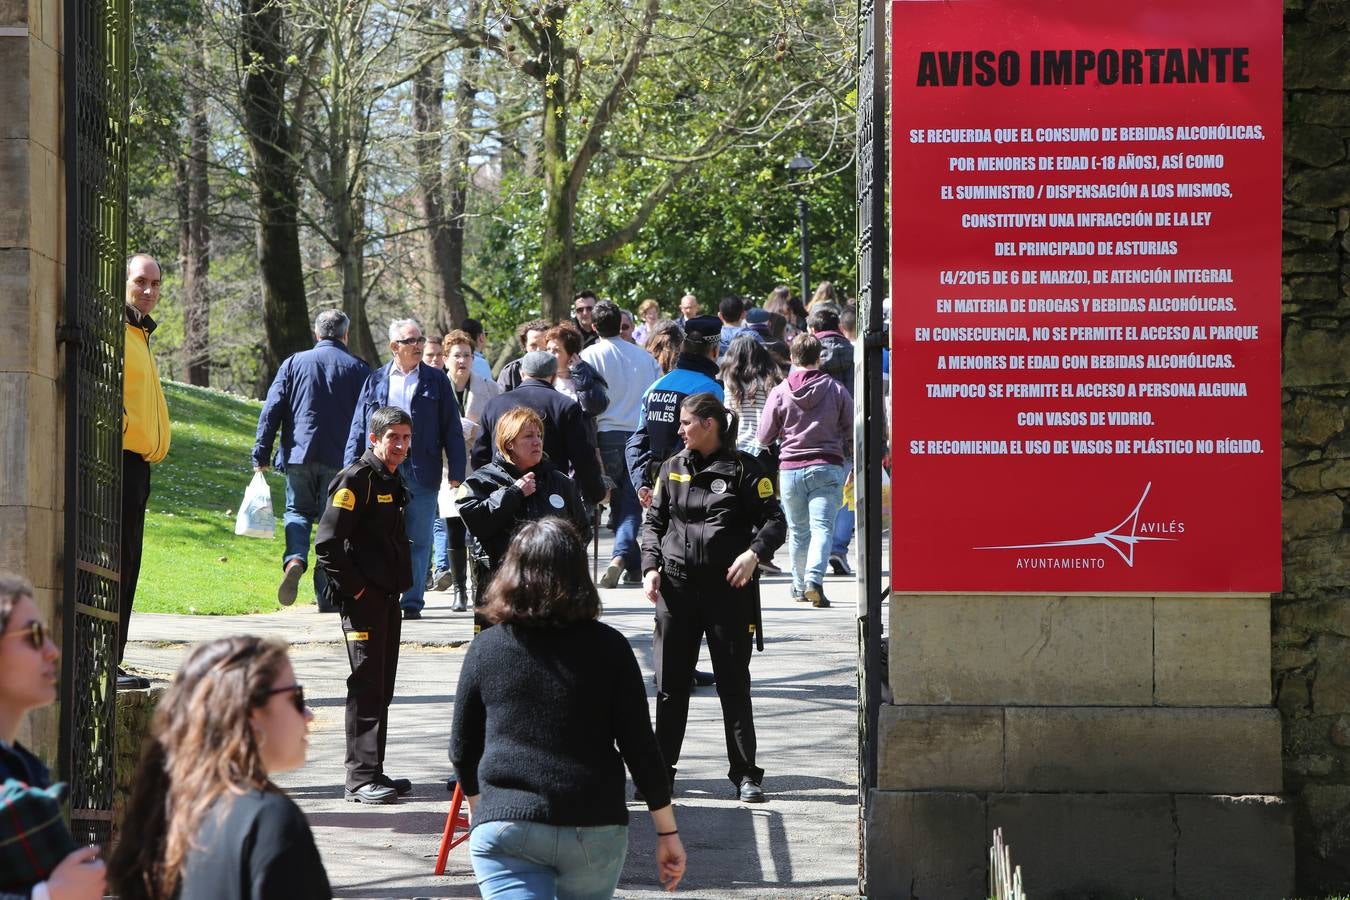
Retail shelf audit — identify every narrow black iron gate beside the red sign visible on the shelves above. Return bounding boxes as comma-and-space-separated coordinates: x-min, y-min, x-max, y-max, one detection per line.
853, 0, 890, 895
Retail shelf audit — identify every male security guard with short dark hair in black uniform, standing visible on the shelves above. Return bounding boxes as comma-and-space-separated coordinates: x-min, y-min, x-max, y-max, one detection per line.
315, 406, 413, 803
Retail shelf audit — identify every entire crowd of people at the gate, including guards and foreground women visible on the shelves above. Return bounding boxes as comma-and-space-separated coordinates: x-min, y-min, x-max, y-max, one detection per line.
0, 255, 855, 900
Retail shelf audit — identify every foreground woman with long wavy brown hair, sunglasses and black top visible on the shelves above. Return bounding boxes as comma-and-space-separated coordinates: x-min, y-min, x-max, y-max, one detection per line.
109, 637, 332, 900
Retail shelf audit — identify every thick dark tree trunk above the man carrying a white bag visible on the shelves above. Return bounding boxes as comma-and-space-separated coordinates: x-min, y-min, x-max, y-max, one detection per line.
239, 0, 313, 395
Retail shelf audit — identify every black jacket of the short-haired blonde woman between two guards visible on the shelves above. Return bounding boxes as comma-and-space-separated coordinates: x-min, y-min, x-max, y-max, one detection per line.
459, 453, 591, 569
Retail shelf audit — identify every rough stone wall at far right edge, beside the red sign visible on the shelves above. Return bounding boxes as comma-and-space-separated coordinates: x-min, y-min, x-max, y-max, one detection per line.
1272, 0, 1350, 895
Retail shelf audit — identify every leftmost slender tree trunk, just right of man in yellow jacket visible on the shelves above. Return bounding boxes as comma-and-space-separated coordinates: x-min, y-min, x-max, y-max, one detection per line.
180, 36, 211, 387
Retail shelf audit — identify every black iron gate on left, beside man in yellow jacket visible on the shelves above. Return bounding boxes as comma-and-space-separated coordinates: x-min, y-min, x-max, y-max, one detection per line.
58, 0, 130, 845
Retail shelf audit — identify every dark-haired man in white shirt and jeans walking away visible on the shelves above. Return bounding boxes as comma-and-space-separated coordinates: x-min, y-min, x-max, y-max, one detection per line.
581, 300, 662, 588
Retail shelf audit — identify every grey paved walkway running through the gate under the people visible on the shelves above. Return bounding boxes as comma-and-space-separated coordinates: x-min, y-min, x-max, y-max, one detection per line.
127, 539, 857, 897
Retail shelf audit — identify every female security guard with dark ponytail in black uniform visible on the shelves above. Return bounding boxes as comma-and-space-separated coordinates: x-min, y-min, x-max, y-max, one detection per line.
641, 393, 787, 803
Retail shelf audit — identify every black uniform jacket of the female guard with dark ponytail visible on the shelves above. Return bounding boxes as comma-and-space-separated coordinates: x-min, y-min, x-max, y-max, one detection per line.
641, 447, 787, 582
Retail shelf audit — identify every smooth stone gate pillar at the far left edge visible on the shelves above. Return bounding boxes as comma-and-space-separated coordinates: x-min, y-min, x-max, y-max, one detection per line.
0, 0, 65, 762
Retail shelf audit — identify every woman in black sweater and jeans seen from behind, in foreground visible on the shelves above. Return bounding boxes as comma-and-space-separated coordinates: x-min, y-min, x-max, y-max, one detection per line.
450, 518, 684, 900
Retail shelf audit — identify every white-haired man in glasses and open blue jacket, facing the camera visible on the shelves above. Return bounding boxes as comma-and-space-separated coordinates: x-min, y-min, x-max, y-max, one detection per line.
344, 318, 466, 619
